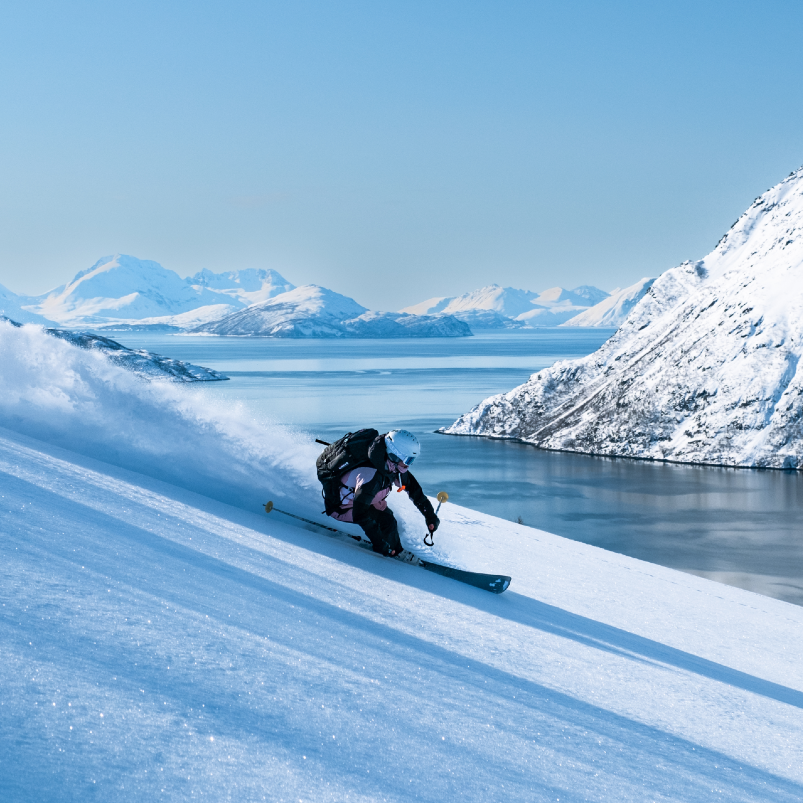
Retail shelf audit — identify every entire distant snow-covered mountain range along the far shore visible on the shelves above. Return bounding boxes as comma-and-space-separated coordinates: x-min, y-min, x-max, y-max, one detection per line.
0, 254, 632, 337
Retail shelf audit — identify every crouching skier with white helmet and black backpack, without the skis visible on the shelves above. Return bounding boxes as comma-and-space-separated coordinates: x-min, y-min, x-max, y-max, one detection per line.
317, 429, 440, 556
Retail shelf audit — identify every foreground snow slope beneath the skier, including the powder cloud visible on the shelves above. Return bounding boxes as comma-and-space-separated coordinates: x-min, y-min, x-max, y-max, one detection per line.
0, 325, 803, 803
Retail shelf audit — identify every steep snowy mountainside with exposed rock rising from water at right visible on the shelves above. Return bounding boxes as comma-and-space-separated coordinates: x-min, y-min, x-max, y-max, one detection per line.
445, 168, 803, 468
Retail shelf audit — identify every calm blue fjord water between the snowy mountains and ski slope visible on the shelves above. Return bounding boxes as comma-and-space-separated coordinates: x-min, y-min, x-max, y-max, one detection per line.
114, 329, 803, 604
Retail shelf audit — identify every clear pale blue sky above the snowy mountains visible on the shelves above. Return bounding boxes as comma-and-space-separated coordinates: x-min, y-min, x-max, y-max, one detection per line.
0, 0, 803, 309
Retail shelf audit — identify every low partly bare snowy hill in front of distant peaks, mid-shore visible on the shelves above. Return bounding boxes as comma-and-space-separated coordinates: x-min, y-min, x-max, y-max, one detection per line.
188, 284, 471, 338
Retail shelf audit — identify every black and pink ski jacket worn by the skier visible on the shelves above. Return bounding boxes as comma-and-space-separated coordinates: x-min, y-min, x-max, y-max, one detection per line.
331, 435, 435, 524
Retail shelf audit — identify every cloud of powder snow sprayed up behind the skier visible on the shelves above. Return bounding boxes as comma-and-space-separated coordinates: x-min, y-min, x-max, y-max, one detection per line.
0, 322, 317, 510
